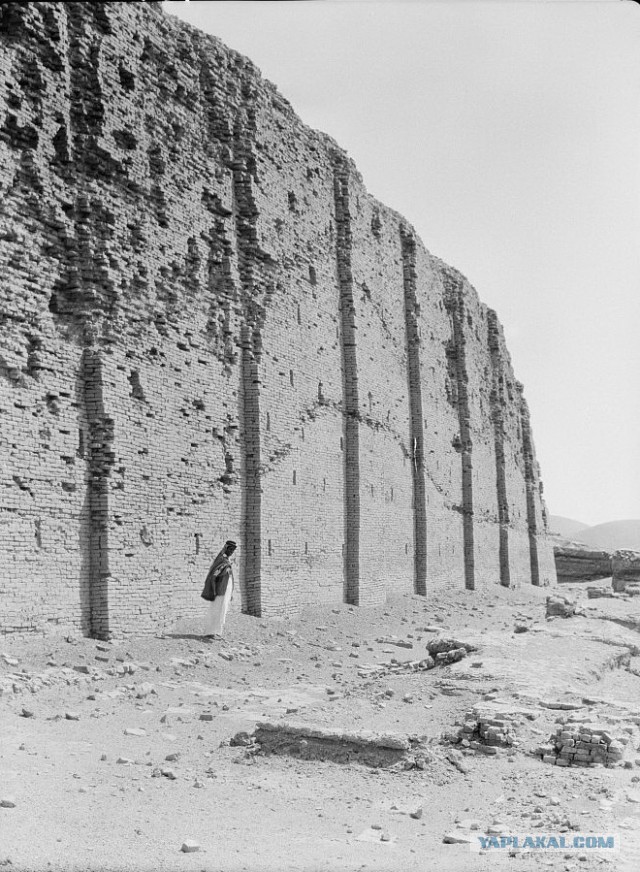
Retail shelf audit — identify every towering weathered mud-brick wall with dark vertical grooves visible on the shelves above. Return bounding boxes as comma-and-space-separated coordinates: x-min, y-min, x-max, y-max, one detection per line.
0, 3, 555, 637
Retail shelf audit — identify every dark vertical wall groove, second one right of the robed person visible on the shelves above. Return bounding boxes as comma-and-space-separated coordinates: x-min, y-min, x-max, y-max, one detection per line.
333, 155, 360, 605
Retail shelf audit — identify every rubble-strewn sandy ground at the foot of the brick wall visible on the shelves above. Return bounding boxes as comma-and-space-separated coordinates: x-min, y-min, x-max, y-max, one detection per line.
0, 585, 640, 872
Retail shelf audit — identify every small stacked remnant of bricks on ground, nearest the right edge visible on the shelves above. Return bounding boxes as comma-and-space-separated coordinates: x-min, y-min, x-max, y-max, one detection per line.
534, 723, 624, 766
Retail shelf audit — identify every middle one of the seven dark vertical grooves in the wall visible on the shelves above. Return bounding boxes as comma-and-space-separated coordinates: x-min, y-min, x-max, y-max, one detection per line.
400, 227, 427, 596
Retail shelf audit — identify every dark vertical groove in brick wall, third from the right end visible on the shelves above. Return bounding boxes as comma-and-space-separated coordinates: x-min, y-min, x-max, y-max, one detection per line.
442, 270, 475, 590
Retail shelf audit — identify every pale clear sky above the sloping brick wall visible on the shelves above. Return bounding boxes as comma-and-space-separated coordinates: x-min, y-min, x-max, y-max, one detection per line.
163, 0, 640, 524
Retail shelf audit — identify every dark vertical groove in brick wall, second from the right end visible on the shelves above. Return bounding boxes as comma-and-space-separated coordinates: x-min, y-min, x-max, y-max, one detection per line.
487, 309, 511, 587
